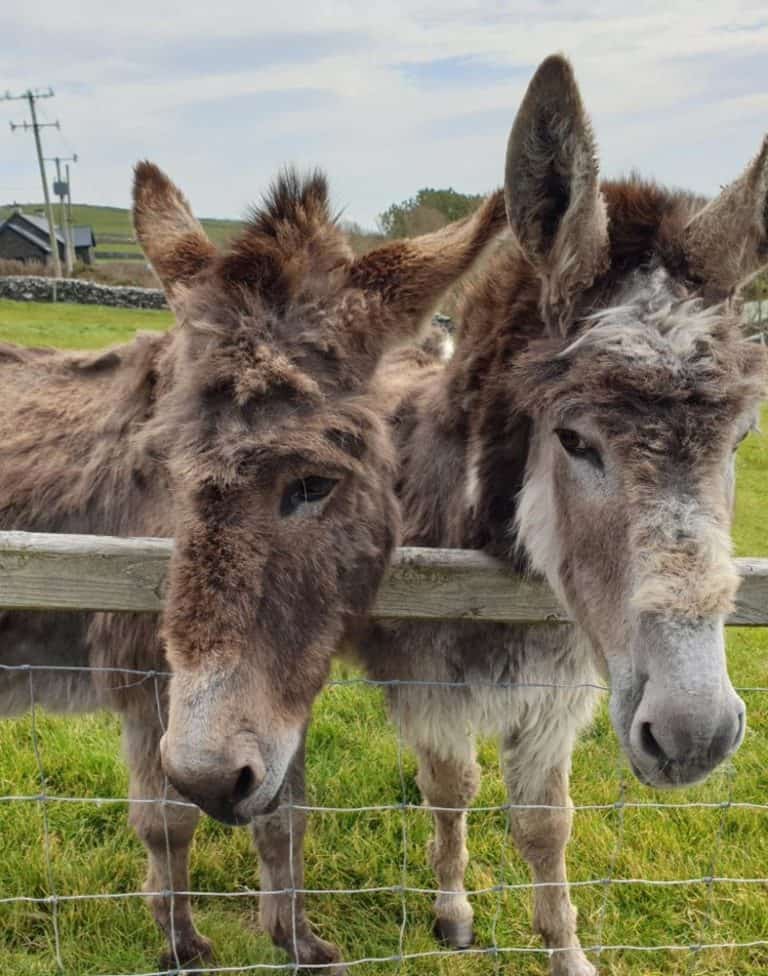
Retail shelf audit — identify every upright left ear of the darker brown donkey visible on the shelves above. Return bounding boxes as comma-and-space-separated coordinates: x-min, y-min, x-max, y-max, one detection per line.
133, 161, 216, 300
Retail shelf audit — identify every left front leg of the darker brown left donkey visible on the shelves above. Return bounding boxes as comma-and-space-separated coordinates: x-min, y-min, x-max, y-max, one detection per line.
123, 703, 213, 969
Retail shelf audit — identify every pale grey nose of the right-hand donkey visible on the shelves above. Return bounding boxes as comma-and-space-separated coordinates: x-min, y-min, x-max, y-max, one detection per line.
630, 696, 746, 784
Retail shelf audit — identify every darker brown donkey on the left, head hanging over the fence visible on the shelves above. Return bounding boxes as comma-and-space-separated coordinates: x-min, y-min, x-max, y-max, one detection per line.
0, 163, 505, 965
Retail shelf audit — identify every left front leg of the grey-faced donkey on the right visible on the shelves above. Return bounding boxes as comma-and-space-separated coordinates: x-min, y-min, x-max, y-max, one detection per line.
416, 748, 480, 949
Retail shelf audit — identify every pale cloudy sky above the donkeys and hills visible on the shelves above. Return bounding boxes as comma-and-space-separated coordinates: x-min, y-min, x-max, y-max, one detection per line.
0, 0, 768, 227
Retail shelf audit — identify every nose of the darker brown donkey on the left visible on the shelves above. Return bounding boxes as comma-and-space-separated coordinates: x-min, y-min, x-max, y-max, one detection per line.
163, 749, 266, 826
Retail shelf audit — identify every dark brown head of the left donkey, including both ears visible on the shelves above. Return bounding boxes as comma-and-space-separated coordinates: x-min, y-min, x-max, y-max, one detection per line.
134, 163, 504, 823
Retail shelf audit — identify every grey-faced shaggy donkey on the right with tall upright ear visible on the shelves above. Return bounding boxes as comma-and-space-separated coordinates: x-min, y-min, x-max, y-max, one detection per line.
361, 57, 768, 976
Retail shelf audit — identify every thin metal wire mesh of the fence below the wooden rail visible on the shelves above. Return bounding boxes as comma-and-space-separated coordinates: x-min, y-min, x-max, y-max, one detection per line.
0, 665, 768, 976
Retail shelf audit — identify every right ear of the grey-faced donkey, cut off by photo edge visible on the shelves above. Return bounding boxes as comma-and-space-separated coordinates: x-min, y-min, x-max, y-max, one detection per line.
683, 136, 768, 297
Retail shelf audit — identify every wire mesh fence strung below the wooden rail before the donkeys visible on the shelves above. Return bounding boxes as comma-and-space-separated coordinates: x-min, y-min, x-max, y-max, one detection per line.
0, 665, 768, 976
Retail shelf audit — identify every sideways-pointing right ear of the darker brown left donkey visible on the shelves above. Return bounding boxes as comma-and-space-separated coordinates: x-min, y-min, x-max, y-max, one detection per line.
347, 190, 506, 344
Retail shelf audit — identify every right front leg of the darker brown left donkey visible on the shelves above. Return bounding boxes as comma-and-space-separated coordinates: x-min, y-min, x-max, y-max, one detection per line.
251, 740, 345, 976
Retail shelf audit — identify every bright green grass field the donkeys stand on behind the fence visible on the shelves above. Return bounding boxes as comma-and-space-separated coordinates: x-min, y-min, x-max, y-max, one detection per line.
0, 302, 768, 976
